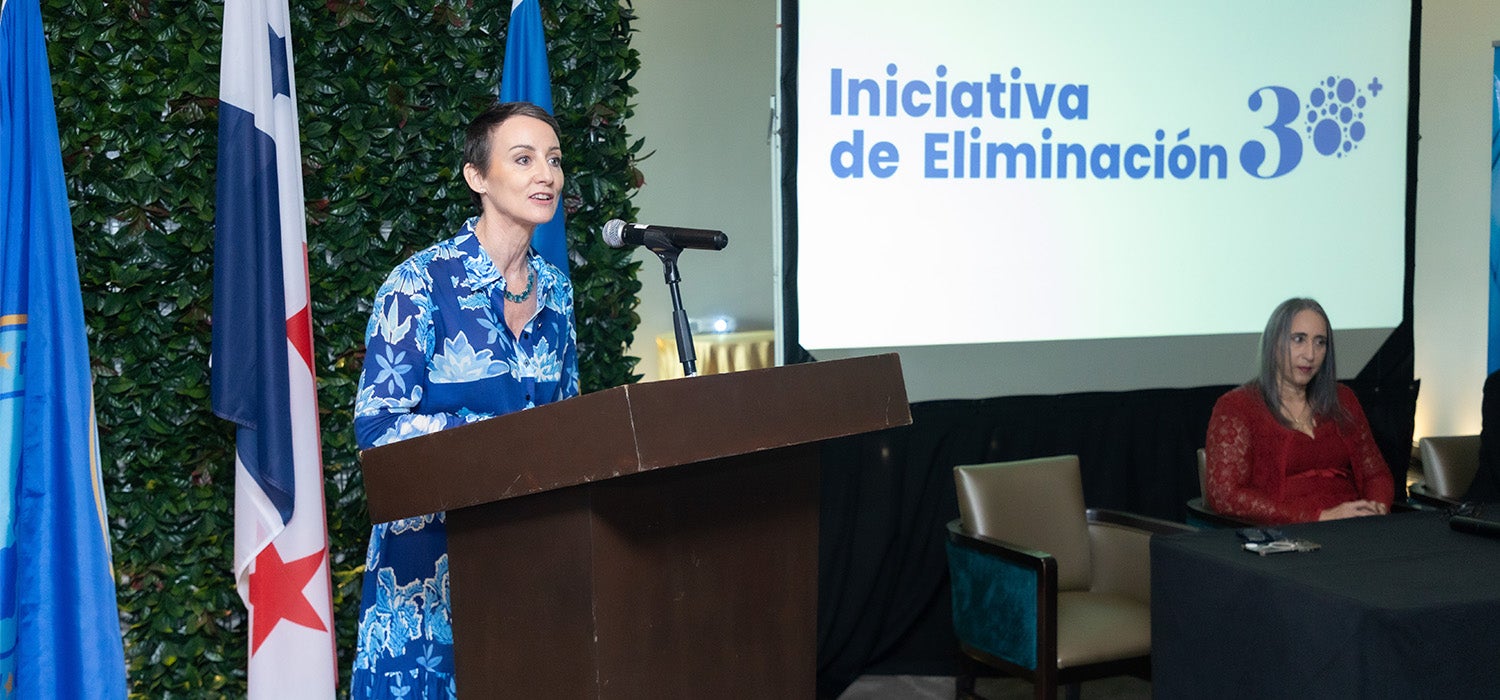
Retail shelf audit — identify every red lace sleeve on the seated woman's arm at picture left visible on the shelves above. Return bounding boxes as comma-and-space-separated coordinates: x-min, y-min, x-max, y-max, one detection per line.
1203, 387, 1319, 525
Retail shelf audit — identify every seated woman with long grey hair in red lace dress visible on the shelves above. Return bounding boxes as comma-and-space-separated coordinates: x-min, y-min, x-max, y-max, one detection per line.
1205, 298, 1394, 525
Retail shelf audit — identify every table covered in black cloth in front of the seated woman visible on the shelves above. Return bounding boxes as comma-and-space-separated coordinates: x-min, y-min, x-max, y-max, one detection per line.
1151, 513, 1500, 700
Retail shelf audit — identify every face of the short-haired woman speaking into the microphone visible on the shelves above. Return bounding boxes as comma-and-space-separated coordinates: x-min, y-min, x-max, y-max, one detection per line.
464, 115, 563, 229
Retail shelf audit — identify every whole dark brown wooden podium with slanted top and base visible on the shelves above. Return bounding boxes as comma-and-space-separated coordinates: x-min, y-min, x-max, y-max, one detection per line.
362, 355, 911, 700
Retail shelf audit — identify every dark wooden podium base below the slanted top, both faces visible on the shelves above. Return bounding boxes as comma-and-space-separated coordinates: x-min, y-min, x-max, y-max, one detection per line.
449, 445, 819, 700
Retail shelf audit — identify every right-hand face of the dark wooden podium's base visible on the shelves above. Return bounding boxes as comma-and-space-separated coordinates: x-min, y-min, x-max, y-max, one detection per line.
594, 447, 819, 699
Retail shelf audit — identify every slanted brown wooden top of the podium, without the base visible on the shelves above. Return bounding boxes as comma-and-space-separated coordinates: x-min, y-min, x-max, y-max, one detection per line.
360, 354, 912, 523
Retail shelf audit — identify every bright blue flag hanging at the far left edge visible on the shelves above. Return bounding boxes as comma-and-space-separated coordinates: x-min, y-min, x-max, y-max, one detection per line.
0, 0, 126, 699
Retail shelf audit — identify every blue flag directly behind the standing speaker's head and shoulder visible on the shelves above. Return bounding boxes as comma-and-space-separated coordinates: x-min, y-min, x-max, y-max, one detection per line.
500, 0, 569, 274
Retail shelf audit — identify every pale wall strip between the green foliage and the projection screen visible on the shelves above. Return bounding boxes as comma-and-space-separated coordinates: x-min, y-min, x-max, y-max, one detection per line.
629, 0, 777, 381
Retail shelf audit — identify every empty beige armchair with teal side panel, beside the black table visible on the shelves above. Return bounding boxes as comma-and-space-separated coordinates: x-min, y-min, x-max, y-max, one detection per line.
948, 456, 1193, 700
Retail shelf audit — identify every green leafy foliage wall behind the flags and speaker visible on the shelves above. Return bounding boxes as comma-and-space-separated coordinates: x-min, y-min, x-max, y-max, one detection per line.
42, 0, 641, 699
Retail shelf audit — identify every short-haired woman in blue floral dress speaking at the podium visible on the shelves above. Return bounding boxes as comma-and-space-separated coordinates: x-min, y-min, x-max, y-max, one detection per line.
350, 102, 578, 699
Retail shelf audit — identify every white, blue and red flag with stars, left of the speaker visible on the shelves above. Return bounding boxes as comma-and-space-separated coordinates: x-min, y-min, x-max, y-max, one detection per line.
212, 0, 338, 699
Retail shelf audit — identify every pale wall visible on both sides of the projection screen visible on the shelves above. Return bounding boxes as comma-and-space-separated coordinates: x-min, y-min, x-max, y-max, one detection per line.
630, 0, 1500, 436
